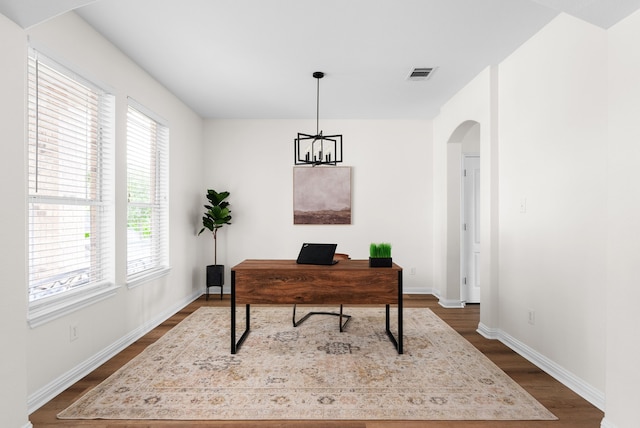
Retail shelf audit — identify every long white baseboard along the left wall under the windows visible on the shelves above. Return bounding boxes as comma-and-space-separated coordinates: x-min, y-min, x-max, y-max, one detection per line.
26, 290, 202, 412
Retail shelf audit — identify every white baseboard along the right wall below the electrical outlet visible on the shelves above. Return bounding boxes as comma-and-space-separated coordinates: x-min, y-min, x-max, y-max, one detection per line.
477, 323, 614, 412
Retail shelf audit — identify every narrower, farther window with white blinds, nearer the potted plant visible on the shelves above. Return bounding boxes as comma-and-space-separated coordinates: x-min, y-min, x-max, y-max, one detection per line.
127, 99, 169, 286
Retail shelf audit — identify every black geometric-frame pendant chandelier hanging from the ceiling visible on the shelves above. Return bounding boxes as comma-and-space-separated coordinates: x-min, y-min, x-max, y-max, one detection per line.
293, 71, 342, 166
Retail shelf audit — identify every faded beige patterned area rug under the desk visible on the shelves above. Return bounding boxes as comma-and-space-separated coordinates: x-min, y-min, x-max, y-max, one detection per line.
58, 306, 556, 420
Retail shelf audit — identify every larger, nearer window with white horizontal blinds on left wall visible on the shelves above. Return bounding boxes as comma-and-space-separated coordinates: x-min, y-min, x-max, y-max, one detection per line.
28, 49, 114, 325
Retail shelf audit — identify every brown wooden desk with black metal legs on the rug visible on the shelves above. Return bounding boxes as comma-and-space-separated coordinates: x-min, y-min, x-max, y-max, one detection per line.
231, 260, 402, 354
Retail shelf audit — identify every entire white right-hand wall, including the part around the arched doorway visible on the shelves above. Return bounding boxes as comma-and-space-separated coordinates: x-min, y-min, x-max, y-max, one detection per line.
434, 15, 608, 408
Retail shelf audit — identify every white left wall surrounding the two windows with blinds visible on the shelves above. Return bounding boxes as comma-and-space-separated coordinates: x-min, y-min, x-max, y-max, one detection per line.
0, 13, 204, 418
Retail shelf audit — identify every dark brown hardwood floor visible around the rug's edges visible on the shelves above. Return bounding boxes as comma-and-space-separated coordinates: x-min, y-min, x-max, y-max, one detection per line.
29, 296, 604, 428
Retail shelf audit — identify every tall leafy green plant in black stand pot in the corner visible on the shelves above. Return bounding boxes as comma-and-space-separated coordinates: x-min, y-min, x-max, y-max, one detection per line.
198, 189, 231, 300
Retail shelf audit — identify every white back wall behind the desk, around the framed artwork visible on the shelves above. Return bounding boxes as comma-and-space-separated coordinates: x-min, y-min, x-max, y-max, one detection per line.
201, 120, 433, 293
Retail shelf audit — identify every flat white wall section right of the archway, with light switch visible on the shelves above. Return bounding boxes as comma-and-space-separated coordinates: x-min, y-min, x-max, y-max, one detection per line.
498, 15, 607, 398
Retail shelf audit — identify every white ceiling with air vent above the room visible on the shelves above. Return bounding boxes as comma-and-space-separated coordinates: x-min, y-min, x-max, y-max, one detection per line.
0, 0, 640, 120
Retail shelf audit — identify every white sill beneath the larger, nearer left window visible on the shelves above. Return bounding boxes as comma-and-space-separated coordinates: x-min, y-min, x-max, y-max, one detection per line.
27, 282, 118, 328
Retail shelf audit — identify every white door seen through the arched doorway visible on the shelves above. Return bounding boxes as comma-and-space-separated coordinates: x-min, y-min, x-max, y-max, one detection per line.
460, 155, 480, 303
